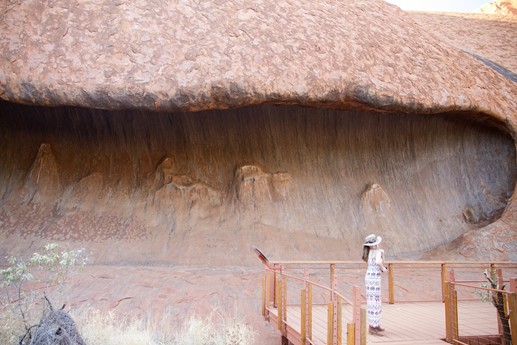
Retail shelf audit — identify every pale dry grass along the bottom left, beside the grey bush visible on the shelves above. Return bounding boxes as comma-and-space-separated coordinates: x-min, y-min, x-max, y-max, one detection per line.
0, 309, 255, 345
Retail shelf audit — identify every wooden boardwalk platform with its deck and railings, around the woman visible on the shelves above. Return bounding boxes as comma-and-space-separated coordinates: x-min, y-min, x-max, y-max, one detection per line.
255, 253, 517, 345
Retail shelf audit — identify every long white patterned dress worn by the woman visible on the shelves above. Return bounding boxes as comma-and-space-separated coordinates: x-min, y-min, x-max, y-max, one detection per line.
364, 249, 382, 327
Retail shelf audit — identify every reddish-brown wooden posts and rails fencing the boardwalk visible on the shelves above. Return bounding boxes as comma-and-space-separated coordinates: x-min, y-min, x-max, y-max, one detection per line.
256, 251, 517, 345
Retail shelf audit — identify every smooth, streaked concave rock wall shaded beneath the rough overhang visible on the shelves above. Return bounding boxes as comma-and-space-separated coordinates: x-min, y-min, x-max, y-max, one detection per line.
0, 102, 517, 265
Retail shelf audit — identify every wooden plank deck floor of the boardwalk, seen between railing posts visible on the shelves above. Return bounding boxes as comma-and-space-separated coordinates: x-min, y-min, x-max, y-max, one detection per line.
268, 301, 498, 345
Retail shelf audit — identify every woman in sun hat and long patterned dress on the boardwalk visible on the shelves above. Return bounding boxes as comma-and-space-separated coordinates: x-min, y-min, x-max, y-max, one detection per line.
363, 234, 387, 334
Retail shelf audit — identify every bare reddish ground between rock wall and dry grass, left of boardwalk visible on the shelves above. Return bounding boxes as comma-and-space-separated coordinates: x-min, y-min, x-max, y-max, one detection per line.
42, 266, 280, 345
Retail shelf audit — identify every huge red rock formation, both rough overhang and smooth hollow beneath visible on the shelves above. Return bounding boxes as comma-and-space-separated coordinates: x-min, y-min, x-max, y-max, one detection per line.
0, 1, 517, 265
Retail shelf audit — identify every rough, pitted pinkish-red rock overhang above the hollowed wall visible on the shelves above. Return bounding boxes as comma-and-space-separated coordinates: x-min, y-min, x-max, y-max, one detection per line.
0, 1, 517, 260
